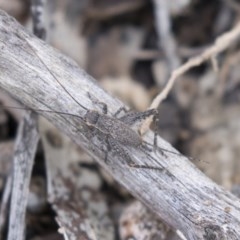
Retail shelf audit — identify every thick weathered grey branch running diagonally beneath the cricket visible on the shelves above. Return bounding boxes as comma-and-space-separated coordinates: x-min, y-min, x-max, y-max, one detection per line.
0, 11, 240, 240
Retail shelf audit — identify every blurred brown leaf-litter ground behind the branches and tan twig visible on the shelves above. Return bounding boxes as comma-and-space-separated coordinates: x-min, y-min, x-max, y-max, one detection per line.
0, 0, 240, 240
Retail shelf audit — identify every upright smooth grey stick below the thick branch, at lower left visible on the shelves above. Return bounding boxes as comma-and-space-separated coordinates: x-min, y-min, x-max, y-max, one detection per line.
8, 113, 39, 240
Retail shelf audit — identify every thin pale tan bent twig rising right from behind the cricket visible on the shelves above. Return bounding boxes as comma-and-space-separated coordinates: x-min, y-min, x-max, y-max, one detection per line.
140, 20, 240, 134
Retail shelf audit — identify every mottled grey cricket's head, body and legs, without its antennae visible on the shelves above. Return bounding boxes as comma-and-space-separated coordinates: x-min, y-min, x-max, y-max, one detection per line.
84, 93, 157, 166
